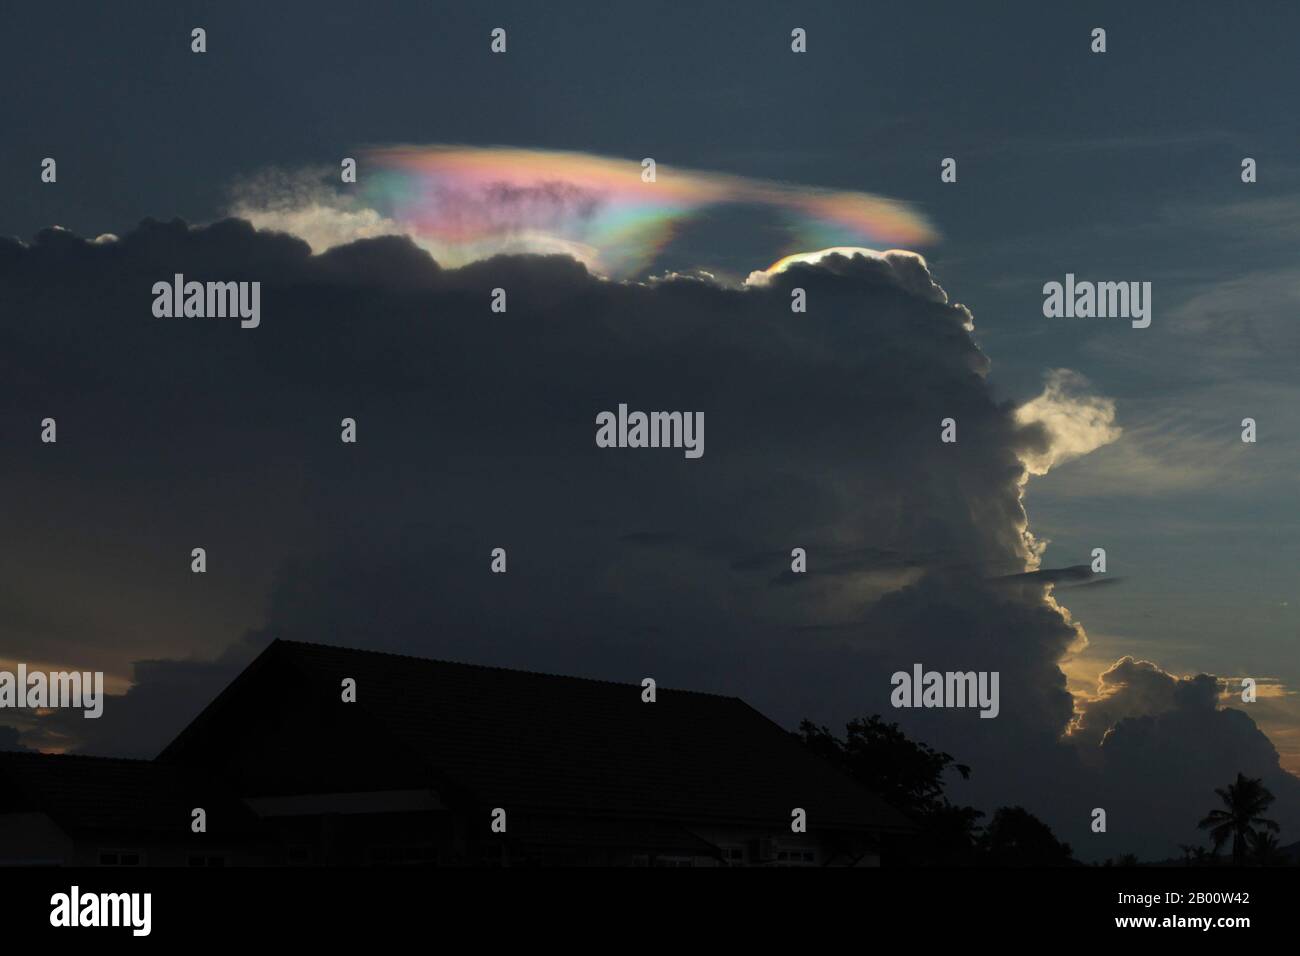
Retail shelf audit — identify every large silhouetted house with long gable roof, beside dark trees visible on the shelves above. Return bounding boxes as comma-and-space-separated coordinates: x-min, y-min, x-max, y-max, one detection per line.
0, 641, 913, 866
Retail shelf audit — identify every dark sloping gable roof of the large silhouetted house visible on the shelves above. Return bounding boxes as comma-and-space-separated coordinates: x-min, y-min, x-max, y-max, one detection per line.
163, 641, 911, 830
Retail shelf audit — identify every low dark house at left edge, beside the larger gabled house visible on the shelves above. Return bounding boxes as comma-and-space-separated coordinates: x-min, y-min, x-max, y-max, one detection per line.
0, 752, 269, 866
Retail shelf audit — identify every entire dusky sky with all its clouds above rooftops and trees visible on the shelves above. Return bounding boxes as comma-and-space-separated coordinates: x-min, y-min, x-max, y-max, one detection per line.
0, 3, 1300, 856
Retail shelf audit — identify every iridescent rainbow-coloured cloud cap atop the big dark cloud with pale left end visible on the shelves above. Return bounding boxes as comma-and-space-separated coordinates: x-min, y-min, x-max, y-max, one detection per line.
233, 146, 936, 277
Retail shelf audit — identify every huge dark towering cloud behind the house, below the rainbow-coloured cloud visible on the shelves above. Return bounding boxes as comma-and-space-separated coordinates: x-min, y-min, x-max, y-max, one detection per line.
0, 221, 1275, 853
